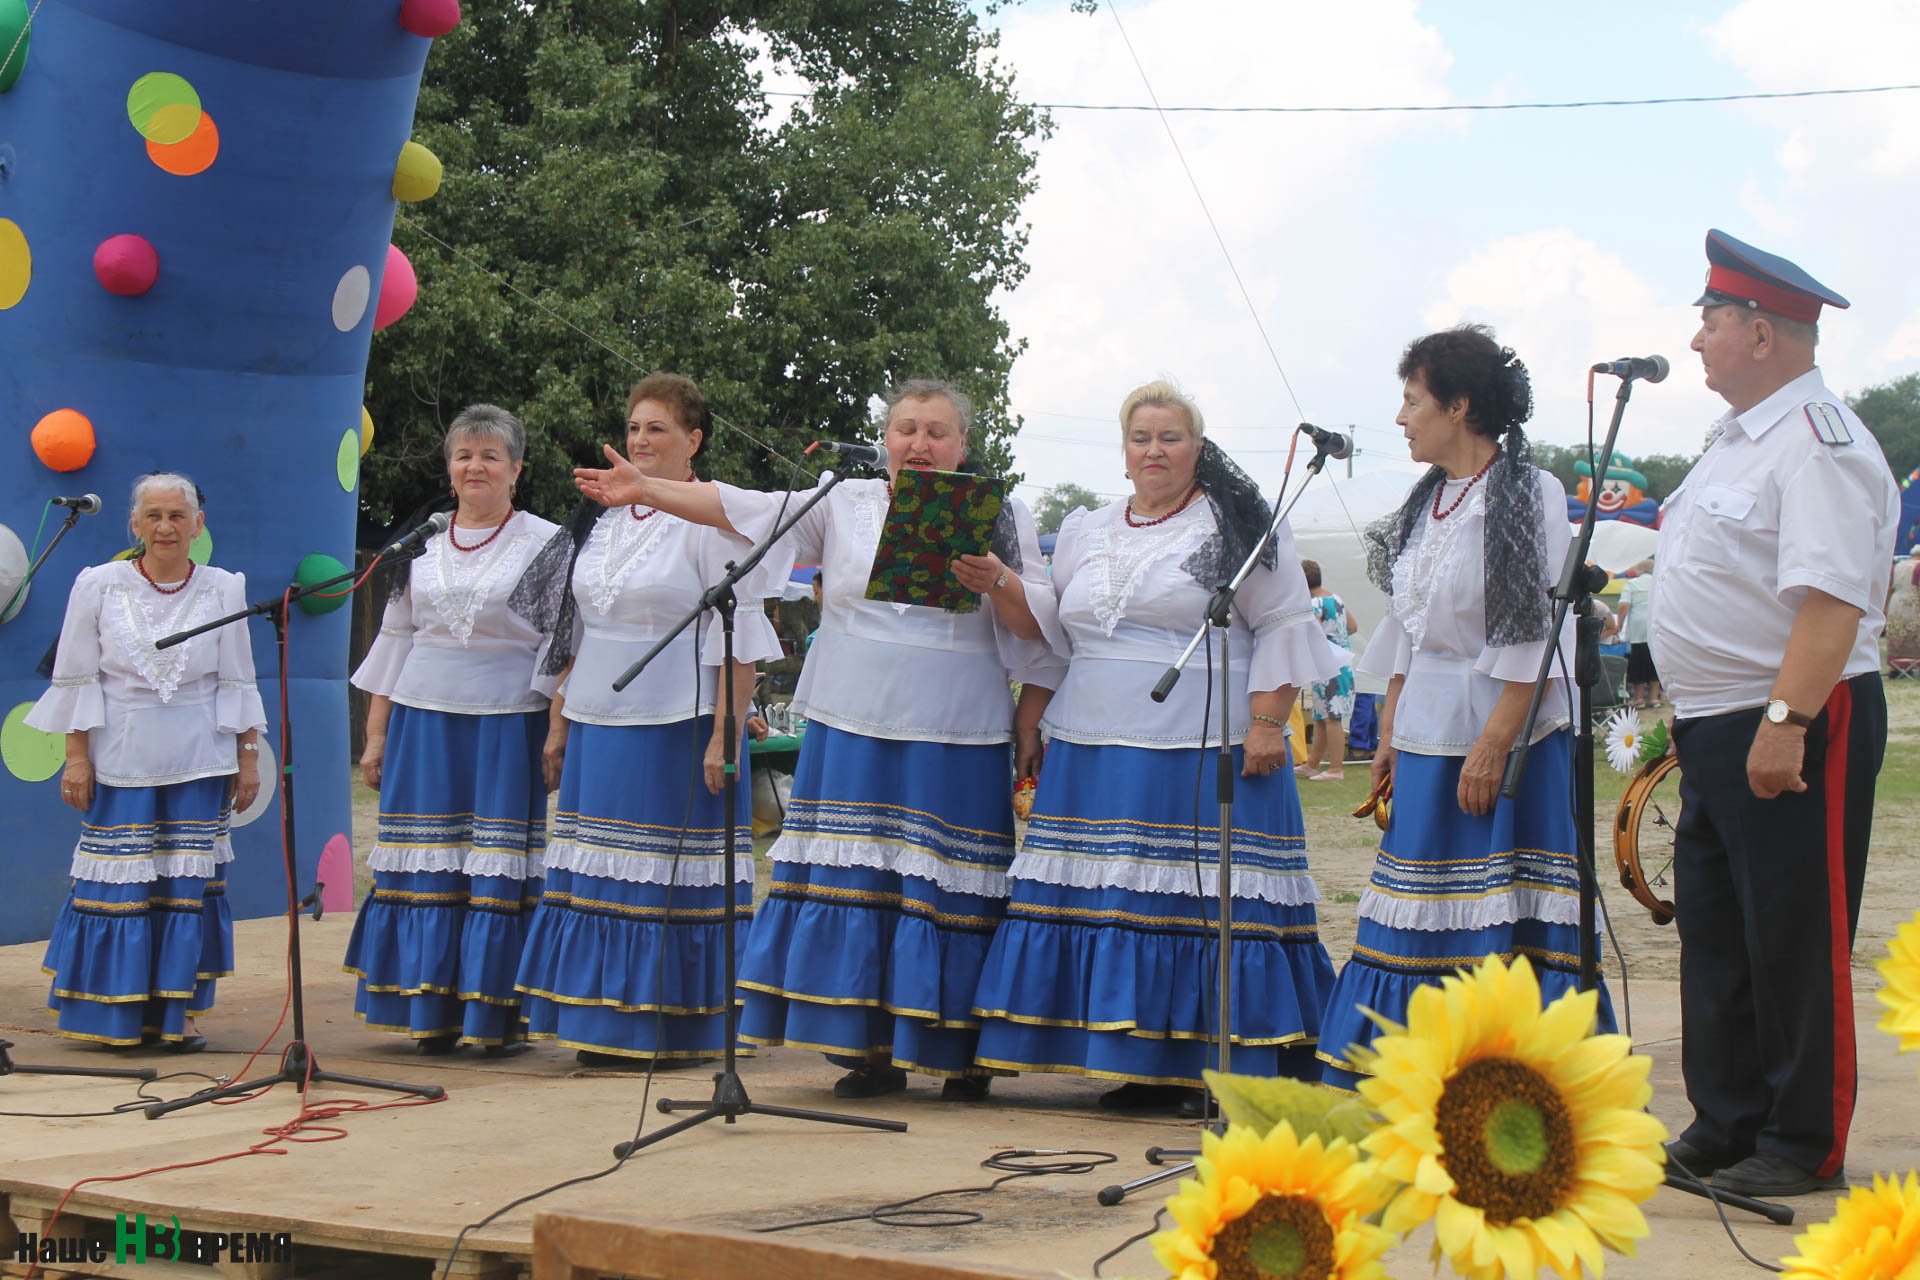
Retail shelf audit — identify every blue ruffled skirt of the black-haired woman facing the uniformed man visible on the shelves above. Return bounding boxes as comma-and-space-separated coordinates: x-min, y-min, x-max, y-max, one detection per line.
1321, 729, 1615, 1088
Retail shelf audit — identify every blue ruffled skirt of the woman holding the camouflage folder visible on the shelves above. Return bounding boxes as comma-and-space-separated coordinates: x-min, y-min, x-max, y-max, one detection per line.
739, 720, 1014, 1077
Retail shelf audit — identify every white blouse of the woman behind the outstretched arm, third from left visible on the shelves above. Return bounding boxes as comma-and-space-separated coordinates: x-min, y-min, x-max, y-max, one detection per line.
534, 507, 787, 725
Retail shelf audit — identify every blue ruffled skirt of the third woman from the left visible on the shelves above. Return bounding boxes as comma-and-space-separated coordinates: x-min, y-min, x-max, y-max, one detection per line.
515, 716, 753, 1057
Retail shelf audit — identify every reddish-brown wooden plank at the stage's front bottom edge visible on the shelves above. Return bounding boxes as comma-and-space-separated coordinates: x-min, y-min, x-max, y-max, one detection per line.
534, 1213, 1043, 1280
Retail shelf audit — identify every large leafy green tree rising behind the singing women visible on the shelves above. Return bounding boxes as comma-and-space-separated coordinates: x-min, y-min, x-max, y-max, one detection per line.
365, 0, 1046, 524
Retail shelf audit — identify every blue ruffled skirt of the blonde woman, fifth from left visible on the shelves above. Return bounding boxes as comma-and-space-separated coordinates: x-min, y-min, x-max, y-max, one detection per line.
973, 741, 1332, 1086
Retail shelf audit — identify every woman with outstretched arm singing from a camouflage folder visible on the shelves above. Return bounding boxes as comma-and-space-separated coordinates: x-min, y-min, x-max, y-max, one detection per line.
574, 380, 1052, 1100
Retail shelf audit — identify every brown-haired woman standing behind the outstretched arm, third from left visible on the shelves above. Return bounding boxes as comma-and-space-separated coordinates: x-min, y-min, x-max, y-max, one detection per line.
516, 374, 781, 1069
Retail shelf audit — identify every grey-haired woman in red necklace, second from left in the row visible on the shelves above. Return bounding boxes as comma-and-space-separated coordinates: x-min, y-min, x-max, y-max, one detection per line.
346, 405, 557, 1054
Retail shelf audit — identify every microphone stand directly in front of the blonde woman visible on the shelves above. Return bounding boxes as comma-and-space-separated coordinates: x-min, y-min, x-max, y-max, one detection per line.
1096, 441, 1334, 1207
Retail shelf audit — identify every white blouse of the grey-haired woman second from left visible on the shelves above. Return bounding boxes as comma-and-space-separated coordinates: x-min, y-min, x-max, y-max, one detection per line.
353, 510, 559, 716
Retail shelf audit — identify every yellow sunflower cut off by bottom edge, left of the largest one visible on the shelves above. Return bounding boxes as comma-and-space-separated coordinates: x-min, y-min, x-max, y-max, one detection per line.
1154, 1121, 1394, 1280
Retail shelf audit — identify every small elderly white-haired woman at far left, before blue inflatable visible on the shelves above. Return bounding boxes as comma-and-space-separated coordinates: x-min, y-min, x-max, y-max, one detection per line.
27, 472, 267, 1052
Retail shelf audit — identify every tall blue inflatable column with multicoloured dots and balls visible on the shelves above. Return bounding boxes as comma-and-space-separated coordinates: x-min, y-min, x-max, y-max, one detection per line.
0, 0, 459, 944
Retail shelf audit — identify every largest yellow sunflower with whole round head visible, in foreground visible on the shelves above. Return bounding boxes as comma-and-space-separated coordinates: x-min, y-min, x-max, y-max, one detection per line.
1359, 956, 1667, 1280
